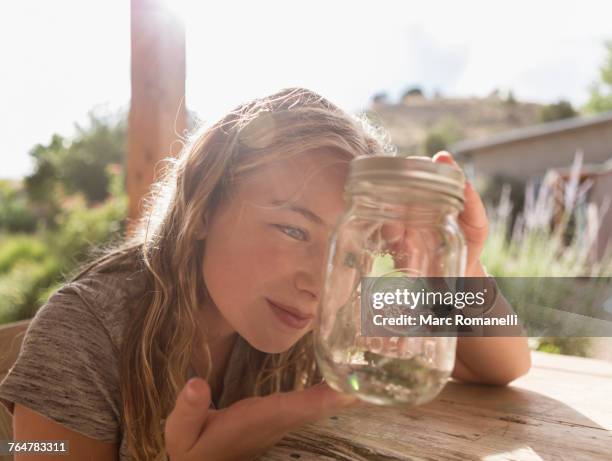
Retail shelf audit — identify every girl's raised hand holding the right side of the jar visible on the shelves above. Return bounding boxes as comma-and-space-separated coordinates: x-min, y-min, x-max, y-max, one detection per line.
433, 152, 489, 277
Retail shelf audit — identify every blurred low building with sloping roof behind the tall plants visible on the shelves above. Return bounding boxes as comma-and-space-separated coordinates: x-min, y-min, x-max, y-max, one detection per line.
449, 112, 612, 258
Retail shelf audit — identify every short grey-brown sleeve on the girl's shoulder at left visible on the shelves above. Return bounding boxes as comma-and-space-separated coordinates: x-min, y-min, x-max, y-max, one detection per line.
0, 282, 121, 442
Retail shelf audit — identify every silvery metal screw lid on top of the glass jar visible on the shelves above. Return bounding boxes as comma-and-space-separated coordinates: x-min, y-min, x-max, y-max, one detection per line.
346, 156, 465, 202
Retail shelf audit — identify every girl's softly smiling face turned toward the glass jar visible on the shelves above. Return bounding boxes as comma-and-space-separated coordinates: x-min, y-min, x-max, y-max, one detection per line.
203, 151, 348, 353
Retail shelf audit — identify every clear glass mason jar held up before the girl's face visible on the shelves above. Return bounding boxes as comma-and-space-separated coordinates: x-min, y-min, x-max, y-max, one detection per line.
314, 157, 467, 405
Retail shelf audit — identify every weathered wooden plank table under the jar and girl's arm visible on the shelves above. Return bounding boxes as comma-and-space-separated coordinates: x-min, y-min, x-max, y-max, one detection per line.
260, 352, 612, 461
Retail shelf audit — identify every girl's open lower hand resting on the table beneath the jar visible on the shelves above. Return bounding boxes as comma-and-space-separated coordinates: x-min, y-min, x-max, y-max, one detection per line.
164, 378, 358, 461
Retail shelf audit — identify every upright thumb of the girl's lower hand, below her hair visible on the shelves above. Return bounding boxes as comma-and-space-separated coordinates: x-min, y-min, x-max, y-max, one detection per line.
165, 378, 211, 456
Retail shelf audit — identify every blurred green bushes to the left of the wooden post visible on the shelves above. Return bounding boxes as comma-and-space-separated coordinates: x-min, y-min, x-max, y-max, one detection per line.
0, 107, 127, 323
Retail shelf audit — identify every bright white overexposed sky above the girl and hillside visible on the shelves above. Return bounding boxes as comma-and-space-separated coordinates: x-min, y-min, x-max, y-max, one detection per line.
0, 0, 612, 178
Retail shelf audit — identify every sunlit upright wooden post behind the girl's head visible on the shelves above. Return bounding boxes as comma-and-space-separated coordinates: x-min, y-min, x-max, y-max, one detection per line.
126, 0, 186, 229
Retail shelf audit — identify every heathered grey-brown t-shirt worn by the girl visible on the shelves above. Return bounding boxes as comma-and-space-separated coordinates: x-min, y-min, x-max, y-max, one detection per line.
0, 272, 250, 460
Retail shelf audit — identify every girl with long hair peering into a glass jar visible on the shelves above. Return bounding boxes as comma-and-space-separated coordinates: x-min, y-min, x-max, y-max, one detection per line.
0, 89, 530, 461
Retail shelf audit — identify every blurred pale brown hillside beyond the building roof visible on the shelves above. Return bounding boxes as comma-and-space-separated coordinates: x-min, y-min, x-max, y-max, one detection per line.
367, 96, 540, 155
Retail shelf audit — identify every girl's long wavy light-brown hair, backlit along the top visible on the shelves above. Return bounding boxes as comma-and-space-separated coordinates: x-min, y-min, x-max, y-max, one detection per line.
68, 88, 393, 461
